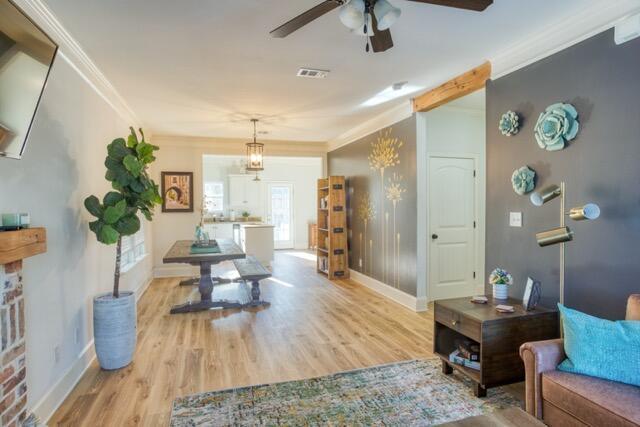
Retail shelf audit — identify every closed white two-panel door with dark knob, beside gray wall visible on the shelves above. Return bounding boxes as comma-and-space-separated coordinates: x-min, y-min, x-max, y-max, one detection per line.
427, 157, 478, 301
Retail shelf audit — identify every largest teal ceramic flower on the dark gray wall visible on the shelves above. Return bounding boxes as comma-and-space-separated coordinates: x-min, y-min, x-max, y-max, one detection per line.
535, 103, 580, 151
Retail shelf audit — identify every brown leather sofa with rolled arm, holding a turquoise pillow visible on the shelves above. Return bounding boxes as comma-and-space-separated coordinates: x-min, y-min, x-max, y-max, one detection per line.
520, 294, 640, 427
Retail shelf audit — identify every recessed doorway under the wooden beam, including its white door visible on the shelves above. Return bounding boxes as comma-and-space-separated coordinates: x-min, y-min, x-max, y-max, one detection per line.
417, 89, 486, 301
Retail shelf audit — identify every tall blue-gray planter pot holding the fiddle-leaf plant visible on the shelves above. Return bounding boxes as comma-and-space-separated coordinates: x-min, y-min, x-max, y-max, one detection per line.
93, 292, 137, 370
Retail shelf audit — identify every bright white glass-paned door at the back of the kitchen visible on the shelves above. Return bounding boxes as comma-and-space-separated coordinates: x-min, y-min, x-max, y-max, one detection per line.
267, 183, 294, 249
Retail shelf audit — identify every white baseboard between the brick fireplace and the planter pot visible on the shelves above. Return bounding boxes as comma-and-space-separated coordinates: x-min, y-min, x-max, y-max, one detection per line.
32, 338, 96, 425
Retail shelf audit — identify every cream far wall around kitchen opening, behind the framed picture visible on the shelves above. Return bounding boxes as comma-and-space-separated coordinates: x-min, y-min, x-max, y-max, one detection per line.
152, 136, 327, 277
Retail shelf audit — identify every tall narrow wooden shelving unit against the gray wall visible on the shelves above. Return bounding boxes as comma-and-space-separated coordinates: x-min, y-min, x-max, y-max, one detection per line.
316, 176, 349, 280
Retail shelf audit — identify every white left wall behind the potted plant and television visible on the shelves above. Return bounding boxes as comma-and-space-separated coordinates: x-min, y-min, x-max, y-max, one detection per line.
0, 56, 152, 420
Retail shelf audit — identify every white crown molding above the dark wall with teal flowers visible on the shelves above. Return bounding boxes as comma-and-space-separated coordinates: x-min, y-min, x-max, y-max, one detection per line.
490, 0, 640, 79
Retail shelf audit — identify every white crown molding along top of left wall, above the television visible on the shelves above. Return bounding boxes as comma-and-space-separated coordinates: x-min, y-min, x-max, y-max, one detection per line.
13, 0, 141, 127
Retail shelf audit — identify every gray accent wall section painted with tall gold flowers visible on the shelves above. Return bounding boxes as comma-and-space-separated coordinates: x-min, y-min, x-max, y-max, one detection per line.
327, 114, 418, 296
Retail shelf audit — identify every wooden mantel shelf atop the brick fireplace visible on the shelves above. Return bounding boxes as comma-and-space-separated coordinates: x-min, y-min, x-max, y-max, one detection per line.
0, 228, 47, 265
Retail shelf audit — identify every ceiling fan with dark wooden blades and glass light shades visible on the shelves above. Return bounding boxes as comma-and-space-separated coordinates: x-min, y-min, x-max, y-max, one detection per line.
270, 0, 493, 52
